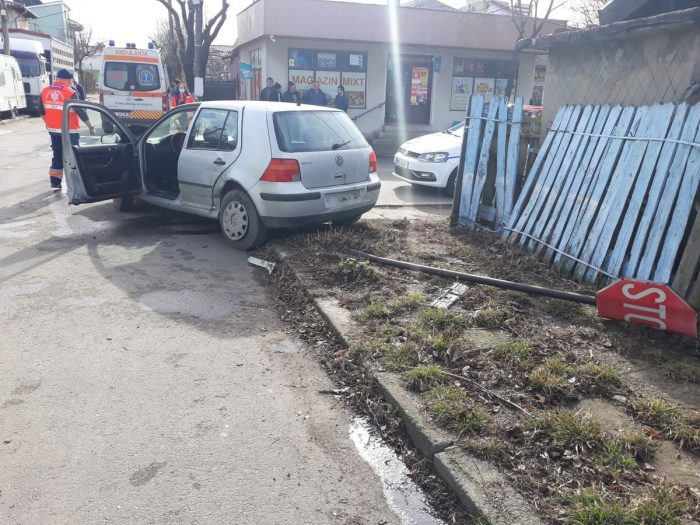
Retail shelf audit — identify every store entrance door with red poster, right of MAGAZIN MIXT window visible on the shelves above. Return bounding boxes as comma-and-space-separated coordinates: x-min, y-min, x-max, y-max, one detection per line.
385, 55, 433, 124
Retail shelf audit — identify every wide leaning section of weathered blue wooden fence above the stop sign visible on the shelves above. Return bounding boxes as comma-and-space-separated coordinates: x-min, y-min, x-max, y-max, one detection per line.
504, 103, 700, 302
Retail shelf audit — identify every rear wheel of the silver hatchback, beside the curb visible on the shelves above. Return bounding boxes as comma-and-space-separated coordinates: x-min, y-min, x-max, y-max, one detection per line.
219, 190, 267, 250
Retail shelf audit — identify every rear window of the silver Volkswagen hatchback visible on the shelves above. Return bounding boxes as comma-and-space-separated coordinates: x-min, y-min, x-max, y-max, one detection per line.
273, 111, 368, 153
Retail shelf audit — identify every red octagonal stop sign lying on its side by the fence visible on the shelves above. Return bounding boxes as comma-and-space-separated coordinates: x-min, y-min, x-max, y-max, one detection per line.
596, 279, 698, 337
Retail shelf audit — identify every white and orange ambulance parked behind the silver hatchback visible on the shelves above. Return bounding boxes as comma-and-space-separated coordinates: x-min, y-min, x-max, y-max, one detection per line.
98, 44, 170, 135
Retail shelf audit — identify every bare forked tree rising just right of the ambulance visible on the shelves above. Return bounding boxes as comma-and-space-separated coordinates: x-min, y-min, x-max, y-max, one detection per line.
156, 0, 229, 88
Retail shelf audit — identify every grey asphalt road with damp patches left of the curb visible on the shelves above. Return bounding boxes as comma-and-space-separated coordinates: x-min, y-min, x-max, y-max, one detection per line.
0, 119, 416, 524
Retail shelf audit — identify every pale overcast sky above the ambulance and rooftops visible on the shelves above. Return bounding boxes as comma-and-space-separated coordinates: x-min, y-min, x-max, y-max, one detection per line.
67, 0, 576, 47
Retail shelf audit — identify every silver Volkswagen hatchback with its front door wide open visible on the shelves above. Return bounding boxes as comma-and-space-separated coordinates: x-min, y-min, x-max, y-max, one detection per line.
63, 100, 381, 250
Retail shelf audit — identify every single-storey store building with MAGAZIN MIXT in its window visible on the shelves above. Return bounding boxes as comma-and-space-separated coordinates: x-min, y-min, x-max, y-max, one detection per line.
232, 0, 563, 143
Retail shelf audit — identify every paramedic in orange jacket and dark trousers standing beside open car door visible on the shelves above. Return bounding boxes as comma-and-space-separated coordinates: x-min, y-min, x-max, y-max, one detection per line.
39, 69, 95, 191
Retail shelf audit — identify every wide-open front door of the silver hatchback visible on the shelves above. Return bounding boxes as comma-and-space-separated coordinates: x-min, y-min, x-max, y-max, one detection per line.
62, 100, 141, 204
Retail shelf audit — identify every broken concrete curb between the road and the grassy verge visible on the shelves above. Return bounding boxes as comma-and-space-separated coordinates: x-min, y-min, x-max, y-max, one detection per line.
272, 246, 542, 525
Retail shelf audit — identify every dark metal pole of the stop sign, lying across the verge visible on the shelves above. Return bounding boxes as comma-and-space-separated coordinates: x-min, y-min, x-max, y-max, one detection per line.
352, 250, 596, 306
